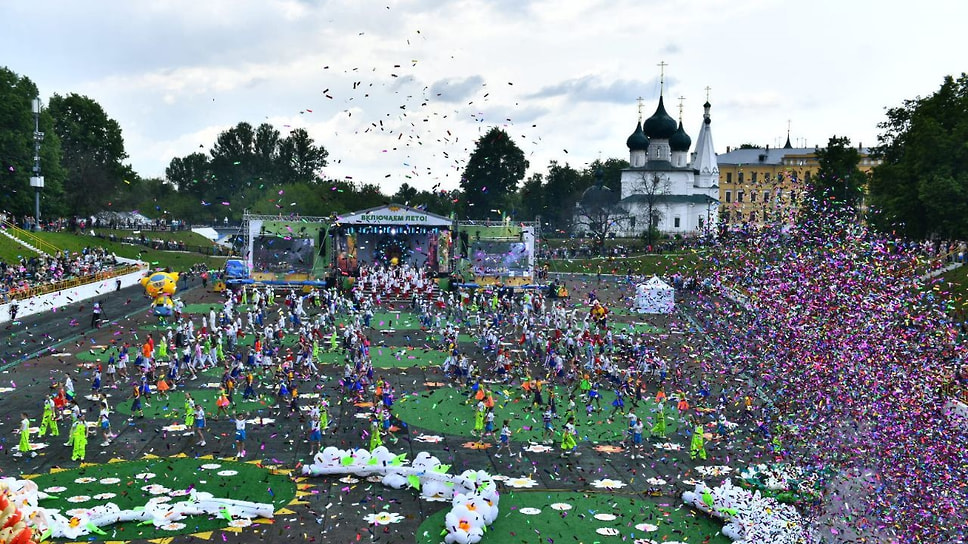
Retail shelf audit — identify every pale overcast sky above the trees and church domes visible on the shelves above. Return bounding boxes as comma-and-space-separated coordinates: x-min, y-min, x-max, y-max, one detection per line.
0, 0, 968, 193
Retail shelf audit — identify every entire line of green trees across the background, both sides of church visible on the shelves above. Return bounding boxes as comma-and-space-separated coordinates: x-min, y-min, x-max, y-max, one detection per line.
0, 63, 968, 239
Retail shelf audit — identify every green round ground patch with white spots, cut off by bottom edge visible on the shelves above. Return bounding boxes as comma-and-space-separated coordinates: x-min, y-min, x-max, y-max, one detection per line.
416, 488, 731, 544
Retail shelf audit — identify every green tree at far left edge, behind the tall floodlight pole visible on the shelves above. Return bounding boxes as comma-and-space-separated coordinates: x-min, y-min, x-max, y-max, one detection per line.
0, 67, 66, 217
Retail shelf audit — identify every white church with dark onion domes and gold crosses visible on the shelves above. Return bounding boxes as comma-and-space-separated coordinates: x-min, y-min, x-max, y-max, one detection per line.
615, 93, 719, 236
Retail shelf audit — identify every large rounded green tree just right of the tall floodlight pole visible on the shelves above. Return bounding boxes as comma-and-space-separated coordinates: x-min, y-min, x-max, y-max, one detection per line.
48, 93, 130, 215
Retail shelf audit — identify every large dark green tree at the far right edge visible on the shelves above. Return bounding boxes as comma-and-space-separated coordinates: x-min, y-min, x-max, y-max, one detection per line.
869, 73, 968, 239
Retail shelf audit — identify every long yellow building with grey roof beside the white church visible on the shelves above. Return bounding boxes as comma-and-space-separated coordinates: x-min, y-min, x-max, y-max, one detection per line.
716, 138, 880, 228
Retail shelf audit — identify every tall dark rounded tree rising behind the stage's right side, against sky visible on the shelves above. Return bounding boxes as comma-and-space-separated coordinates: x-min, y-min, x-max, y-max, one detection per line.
460, 127, 528, 219
